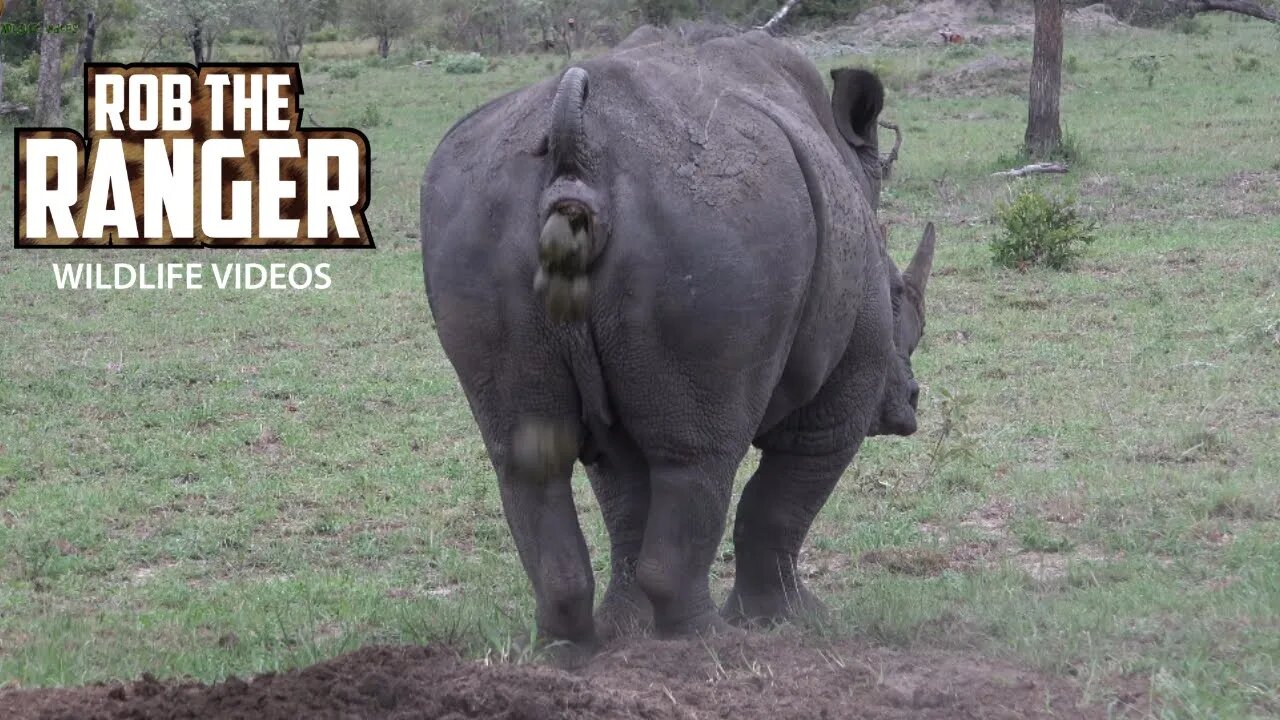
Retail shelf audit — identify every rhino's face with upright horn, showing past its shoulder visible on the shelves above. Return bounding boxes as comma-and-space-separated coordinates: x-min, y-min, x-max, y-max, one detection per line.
867, 223, 934, 436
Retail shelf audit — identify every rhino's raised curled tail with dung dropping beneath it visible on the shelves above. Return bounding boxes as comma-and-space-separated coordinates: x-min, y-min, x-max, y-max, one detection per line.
534, 67, 605, 323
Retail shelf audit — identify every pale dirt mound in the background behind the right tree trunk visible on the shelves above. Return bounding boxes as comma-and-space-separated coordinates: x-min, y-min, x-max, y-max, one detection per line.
794, 0, 1128, 56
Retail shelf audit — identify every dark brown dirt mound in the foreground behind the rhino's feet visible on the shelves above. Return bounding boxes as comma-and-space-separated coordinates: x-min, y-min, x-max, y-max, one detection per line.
0, 635, 1146, 720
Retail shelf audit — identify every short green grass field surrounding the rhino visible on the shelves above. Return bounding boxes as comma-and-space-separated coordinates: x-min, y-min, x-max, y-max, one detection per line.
0, 18, 1280, 717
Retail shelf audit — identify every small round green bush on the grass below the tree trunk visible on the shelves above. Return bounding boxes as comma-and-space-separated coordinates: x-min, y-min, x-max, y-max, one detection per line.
991, 190, 1094, 270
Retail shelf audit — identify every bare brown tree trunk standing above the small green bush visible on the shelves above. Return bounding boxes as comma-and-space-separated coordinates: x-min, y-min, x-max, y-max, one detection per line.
1025, 0, 1062, 158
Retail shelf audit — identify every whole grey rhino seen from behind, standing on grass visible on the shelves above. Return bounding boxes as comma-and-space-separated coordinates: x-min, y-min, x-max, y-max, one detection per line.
421, 28, 933, 651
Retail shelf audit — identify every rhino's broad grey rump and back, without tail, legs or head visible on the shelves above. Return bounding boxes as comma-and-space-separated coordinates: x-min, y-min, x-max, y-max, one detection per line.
422, 33, 873, 443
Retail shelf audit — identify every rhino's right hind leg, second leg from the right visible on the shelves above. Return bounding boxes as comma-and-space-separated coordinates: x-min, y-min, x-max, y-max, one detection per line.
636, 459, 737, 635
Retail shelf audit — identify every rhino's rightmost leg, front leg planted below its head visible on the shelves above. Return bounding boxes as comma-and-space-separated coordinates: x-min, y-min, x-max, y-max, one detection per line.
722, 443, 858, 624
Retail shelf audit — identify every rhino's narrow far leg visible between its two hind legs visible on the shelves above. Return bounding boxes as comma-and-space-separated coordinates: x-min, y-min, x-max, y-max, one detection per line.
586, 448, 653, 641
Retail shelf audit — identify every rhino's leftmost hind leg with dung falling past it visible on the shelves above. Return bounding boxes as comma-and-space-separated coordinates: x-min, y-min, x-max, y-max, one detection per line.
499, 420, 598, 653
